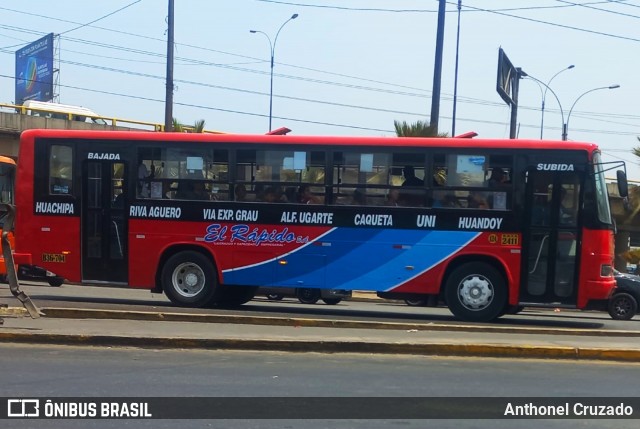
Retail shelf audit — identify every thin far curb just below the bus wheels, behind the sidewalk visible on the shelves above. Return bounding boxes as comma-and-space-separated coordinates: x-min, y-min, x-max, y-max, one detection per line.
40, 307, 640, 337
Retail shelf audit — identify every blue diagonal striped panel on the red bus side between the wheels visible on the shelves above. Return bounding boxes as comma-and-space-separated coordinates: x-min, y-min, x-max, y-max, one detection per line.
225, 228, 479, 291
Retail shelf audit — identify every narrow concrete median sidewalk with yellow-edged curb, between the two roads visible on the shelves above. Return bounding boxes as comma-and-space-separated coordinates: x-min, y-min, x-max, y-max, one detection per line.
0, 307, 640, 362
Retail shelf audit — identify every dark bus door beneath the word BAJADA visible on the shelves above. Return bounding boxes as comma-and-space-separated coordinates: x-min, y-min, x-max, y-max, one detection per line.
82, 159, 128, 283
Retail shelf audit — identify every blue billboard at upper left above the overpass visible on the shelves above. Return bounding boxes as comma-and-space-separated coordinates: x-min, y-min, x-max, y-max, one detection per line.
15, 33, 53, 104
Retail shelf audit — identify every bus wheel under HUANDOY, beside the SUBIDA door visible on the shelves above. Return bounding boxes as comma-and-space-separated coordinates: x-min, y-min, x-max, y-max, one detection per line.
445, 262, 508, 322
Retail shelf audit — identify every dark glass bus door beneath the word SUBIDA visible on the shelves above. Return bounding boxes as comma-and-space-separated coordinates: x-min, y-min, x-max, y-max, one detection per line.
520, 171, 581, 306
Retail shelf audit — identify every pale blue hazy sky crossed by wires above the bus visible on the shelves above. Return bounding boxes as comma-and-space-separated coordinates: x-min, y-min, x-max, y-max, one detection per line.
0, 0, 640, 180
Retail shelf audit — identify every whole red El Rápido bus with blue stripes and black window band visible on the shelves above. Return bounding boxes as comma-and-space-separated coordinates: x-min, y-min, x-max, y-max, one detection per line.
16, 130, 626, 321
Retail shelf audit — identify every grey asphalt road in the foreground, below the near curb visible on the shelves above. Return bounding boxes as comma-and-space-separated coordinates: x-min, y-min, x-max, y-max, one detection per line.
0, 344, 640, 429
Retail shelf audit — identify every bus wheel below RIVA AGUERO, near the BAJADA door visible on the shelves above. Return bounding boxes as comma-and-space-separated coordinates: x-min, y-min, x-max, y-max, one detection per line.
161, 251, 219, 307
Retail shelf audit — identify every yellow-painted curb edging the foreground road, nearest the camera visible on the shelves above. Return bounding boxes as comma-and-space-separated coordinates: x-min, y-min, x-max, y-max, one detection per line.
0, 332, 640, 362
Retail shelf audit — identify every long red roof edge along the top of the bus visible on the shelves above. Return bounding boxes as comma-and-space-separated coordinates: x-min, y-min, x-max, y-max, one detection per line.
21, 129, 598, 152
